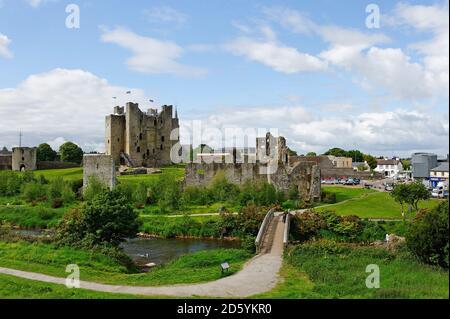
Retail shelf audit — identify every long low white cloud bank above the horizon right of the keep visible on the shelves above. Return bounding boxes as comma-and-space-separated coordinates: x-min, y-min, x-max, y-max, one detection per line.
182, 105, 449, 156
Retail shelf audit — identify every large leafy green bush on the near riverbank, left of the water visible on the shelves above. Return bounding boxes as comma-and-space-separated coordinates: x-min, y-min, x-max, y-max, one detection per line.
57, 190, 141, 247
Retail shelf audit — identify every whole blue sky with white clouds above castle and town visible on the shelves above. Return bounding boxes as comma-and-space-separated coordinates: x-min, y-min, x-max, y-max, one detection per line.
0, 0, 449, 157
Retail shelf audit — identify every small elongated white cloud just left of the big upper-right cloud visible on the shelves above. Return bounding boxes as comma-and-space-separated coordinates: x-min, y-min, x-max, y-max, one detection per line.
225, 26, 327, 74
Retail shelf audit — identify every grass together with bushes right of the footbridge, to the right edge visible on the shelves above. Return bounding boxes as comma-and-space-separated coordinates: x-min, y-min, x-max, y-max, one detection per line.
258, 201, 449, 299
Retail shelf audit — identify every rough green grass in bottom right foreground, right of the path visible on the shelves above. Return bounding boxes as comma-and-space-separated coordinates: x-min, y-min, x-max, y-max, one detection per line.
255, 244, 449, 299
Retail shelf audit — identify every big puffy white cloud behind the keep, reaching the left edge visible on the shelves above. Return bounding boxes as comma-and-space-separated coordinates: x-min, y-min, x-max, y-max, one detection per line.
0, 69, 148, 151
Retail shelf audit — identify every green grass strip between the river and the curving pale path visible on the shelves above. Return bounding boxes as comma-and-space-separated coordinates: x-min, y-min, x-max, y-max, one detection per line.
0, 241, 251, 286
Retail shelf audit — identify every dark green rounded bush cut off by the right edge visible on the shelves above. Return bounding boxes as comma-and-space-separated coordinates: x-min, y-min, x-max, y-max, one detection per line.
406, 201, 449, 268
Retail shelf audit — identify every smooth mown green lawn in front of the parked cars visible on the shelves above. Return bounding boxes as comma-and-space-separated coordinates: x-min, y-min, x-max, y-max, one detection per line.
315, 192, 439, 219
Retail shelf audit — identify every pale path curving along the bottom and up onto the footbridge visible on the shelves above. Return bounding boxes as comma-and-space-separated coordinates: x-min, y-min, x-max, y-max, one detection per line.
0, 218, 284, 298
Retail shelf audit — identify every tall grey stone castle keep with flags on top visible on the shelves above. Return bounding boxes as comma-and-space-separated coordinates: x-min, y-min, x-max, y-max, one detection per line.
105, 102, 179, 167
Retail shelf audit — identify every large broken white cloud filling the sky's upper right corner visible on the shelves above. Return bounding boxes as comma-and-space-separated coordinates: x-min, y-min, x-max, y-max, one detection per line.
263, 4, 449, 100
